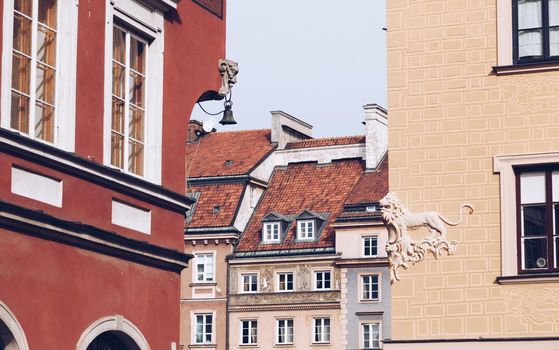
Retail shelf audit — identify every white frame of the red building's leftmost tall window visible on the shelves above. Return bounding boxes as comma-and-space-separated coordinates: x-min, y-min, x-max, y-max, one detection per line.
0, 0, 78, 152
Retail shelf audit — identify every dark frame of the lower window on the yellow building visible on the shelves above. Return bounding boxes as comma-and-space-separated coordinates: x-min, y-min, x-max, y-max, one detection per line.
513, 164, 559, 275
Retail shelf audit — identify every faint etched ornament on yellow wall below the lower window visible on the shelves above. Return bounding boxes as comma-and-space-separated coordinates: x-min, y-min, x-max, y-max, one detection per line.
503, 287, 559, 325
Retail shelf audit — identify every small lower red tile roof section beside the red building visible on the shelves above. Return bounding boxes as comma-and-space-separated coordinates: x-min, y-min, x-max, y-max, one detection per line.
186, 183, 245, 228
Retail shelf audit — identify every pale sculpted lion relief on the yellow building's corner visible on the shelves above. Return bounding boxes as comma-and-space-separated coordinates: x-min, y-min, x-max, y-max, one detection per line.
380, 192, 474, 283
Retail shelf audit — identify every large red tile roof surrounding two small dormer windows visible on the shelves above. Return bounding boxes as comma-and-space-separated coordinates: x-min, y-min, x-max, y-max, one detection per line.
236, 159, 363, 252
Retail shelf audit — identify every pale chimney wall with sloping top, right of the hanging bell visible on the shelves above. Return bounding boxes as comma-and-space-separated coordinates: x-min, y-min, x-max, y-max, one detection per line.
270, 111, 312, 149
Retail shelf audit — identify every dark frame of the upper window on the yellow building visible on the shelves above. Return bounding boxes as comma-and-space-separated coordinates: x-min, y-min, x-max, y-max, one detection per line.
512, 0, 559, 65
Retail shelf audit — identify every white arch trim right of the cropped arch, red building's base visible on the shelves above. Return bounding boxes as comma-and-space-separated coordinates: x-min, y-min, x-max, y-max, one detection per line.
76, 315, 150, 350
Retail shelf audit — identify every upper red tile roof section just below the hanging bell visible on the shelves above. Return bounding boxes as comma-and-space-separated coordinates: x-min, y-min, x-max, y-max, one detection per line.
186, 129, 275, 178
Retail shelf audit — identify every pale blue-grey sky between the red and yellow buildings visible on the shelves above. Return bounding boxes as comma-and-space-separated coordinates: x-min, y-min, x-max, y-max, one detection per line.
191, 0, 386, 137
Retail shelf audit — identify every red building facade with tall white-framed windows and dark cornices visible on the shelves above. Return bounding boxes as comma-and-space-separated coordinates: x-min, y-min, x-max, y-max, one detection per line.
0, 0, 225, 350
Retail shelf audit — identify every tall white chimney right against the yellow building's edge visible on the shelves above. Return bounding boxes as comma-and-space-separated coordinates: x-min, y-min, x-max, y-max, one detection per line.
363, 103, 388, 169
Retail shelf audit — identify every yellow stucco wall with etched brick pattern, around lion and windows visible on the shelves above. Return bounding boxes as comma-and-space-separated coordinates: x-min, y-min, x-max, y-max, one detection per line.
386, 0, 559, 339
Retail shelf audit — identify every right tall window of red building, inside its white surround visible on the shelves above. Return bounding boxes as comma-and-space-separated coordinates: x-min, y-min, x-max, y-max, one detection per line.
111, 26, 148, 175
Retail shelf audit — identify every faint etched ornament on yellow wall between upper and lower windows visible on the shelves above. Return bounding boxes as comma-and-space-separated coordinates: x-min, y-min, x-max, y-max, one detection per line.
501, 75, 559, 112
